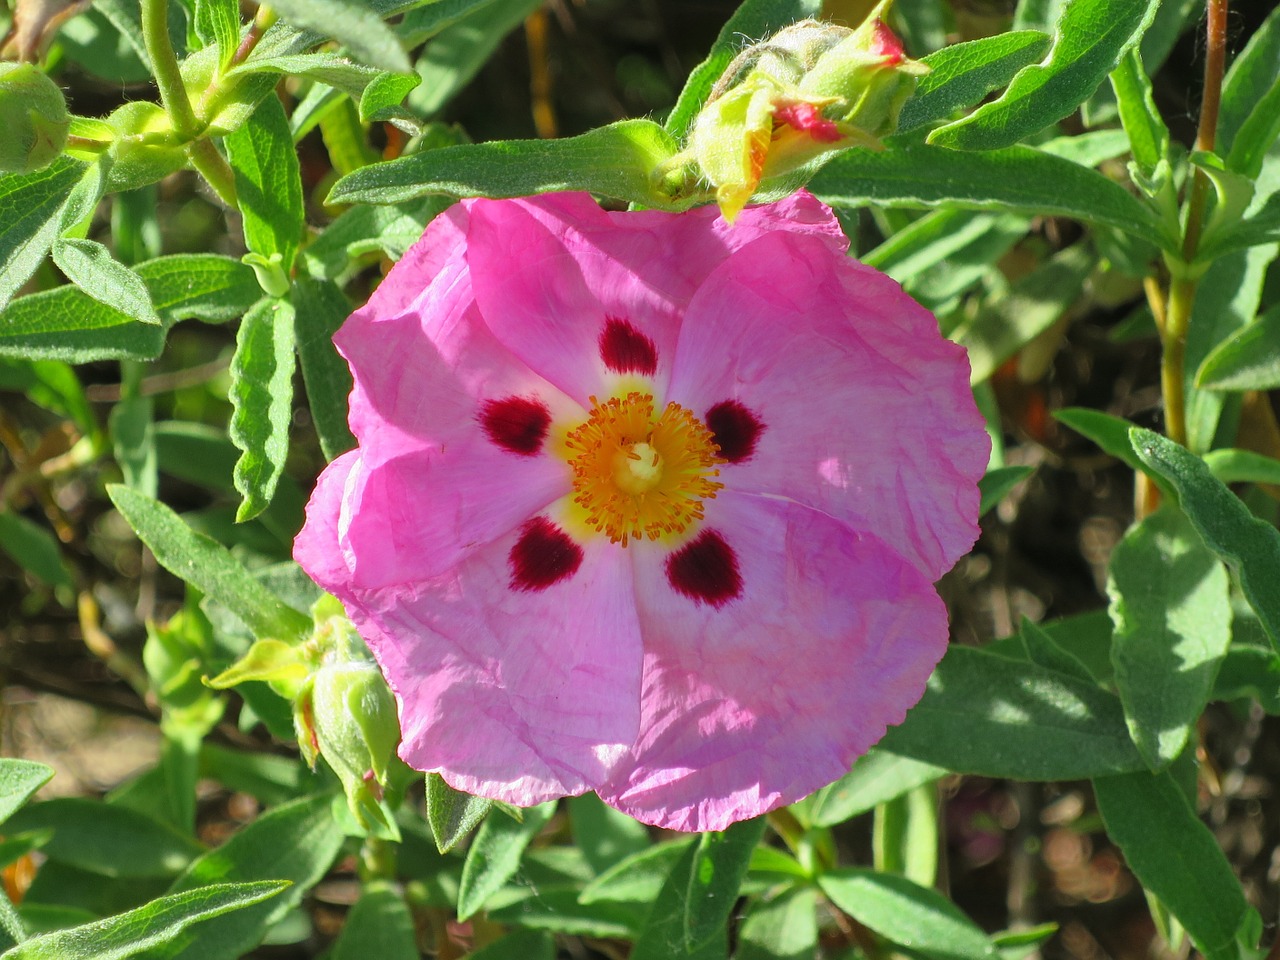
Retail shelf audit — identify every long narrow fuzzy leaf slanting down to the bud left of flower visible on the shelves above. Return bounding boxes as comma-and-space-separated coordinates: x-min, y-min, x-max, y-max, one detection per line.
106, 484, 311, 640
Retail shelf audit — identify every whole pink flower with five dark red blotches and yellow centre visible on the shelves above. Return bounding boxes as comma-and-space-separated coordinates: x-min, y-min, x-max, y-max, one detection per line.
294, 193, 988, 829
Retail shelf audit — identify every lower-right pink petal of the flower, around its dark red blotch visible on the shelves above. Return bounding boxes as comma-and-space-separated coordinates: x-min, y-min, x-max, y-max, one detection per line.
596, 493, 947, 831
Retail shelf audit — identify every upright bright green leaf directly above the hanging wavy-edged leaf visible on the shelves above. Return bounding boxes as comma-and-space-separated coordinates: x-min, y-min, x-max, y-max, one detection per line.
227, 98, 303, 275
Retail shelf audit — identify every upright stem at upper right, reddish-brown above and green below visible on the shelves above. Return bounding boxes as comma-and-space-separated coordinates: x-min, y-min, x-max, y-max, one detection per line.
1160, 0, 1228, 445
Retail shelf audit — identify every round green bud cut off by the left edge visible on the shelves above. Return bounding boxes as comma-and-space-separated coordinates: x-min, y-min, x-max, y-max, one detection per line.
0, 63, 70, 173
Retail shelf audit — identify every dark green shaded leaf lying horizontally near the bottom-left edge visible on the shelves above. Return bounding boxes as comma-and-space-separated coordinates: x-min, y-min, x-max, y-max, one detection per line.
8, 797, 204, 878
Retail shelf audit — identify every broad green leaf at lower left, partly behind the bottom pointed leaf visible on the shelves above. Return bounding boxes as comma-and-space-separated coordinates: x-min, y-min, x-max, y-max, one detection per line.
146, 794, 343, 960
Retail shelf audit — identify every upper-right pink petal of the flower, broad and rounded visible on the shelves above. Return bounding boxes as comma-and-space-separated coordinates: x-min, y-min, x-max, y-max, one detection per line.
671, 233, 989, 580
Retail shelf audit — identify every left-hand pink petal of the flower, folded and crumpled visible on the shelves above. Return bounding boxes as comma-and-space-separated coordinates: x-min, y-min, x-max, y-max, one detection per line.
325, 233, 582, 588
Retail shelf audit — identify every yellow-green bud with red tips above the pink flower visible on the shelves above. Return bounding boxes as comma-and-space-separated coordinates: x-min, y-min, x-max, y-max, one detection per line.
689, 0, 927, 220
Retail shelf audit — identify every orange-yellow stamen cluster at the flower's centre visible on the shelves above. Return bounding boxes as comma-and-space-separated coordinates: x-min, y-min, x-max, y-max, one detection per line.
564, 393, 726, 547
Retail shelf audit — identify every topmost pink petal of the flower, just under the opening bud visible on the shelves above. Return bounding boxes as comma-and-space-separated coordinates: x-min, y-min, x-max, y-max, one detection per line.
467, 193, 849, 404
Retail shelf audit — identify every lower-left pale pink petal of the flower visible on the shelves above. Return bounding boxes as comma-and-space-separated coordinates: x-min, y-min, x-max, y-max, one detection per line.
316, 506, 641, 806
